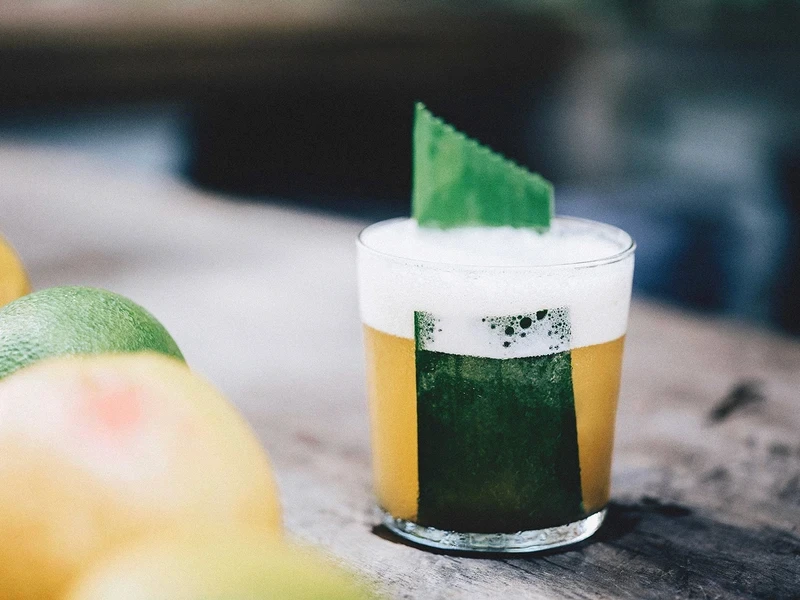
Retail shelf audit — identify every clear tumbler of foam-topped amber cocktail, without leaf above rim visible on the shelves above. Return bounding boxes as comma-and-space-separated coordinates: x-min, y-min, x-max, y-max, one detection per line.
358, 104, 634, 552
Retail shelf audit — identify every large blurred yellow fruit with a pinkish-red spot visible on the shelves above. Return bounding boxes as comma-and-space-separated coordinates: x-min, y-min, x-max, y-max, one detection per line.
0, 353, 281, 600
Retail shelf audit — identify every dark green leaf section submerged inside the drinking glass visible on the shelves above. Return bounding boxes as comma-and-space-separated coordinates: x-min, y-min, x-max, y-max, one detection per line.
415, 309, 584, 533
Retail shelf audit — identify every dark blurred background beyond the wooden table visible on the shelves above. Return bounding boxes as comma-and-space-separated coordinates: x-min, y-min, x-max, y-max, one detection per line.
0, 0, 800, 335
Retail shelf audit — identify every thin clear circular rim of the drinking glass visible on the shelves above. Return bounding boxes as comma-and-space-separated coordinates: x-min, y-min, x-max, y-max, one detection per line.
356, 215, 636, 271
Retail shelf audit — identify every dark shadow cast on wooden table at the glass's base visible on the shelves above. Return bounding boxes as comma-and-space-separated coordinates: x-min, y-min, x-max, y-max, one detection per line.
373, 496, 800, 599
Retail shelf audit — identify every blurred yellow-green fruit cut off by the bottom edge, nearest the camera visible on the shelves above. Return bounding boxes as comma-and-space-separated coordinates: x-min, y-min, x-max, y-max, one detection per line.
66, 535, 377, 600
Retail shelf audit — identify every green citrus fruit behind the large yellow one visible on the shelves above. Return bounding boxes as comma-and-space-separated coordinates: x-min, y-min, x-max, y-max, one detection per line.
0, 287, 183, 378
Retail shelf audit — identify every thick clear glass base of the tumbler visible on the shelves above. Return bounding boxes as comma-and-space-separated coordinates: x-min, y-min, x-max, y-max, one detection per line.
378, 509, 606, 553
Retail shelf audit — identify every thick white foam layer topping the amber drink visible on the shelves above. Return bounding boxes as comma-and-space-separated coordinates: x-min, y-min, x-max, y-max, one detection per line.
358, 218, 633, 357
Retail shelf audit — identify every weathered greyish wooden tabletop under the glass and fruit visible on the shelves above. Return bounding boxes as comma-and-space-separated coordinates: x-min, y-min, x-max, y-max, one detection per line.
0, 146, 800, 599
